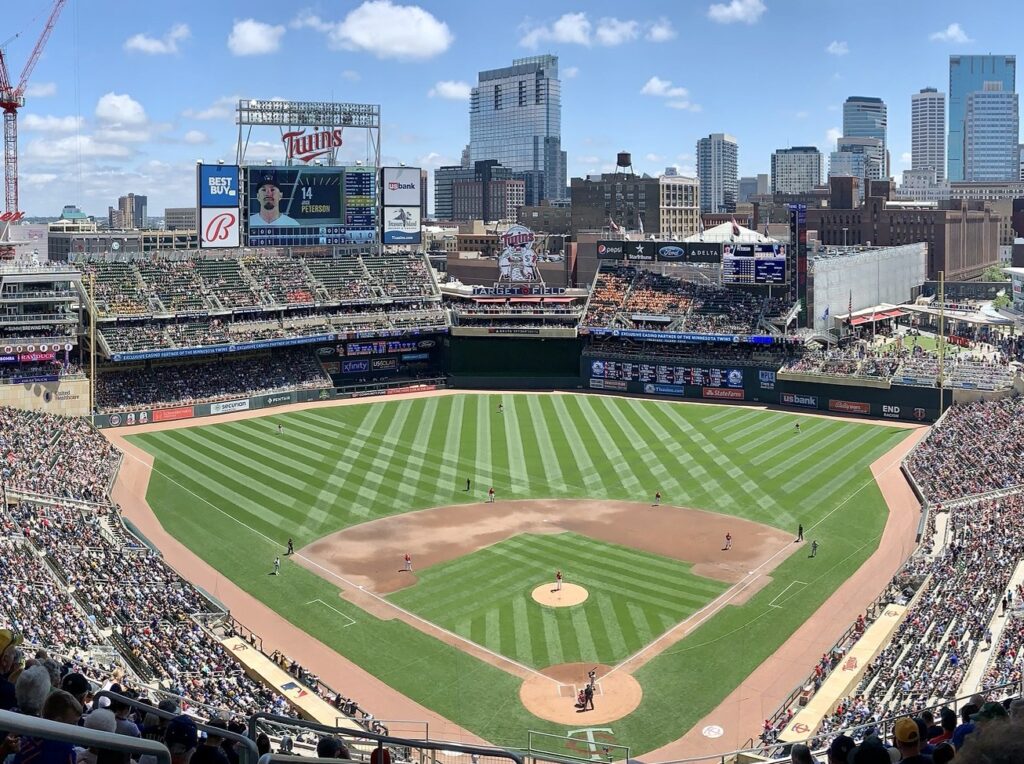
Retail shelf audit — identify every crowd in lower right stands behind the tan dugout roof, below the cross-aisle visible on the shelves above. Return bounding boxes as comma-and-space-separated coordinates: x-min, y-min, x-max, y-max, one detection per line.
762, 487, 1024, 749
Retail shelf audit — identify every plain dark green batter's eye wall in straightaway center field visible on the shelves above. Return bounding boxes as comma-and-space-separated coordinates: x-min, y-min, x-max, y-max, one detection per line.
444, 337, 585, 390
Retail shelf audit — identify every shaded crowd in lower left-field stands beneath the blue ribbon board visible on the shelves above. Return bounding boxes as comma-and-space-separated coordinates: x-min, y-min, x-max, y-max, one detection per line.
96, 347, 331, 413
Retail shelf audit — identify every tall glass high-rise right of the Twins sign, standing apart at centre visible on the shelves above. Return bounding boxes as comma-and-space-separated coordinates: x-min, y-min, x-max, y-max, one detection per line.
469, 55, 566, 204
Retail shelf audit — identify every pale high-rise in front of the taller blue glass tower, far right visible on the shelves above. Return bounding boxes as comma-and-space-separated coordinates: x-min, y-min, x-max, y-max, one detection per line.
964, 81, 1020, 182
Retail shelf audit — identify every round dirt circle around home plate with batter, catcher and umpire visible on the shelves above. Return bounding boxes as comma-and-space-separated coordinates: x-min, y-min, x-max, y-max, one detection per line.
519, 664, 643, 726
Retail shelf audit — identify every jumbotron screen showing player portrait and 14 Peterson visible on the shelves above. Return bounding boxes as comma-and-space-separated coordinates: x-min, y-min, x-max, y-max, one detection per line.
246, 166, 377, 247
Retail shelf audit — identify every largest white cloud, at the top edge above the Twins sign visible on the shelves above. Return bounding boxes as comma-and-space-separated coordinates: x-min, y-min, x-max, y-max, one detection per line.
292, 0, 455, 60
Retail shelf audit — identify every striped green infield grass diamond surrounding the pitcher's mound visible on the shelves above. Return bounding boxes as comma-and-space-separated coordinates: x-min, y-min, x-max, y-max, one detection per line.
388, 533, 728, 668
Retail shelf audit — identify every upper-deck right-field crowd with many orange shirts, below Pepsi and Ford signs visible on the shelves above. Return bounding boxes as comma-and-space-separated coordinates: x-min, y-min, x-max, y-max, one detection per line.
582, 265, 782, 334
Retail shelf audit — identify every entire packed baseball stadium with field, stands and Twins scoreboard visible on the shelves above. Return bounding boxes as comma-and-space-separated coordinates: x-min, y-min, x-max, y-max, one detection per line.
0, 86, 1024, 764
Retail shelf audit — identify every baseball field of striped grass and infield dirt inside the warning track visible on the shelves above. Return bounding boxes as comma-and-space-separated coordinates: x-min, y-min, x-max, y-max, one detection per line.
129, 394, 908, 755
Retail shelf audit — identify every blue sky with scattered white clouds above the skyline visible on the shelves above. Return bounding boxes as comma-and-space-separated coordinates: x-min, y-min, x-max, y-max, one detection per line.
9, 0, 1020, 214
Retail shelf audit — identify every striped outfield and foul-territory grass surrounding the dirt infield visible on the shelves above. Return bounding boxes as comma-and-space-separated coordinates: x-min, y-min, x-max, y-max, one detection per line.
132, 395, 907, 754
